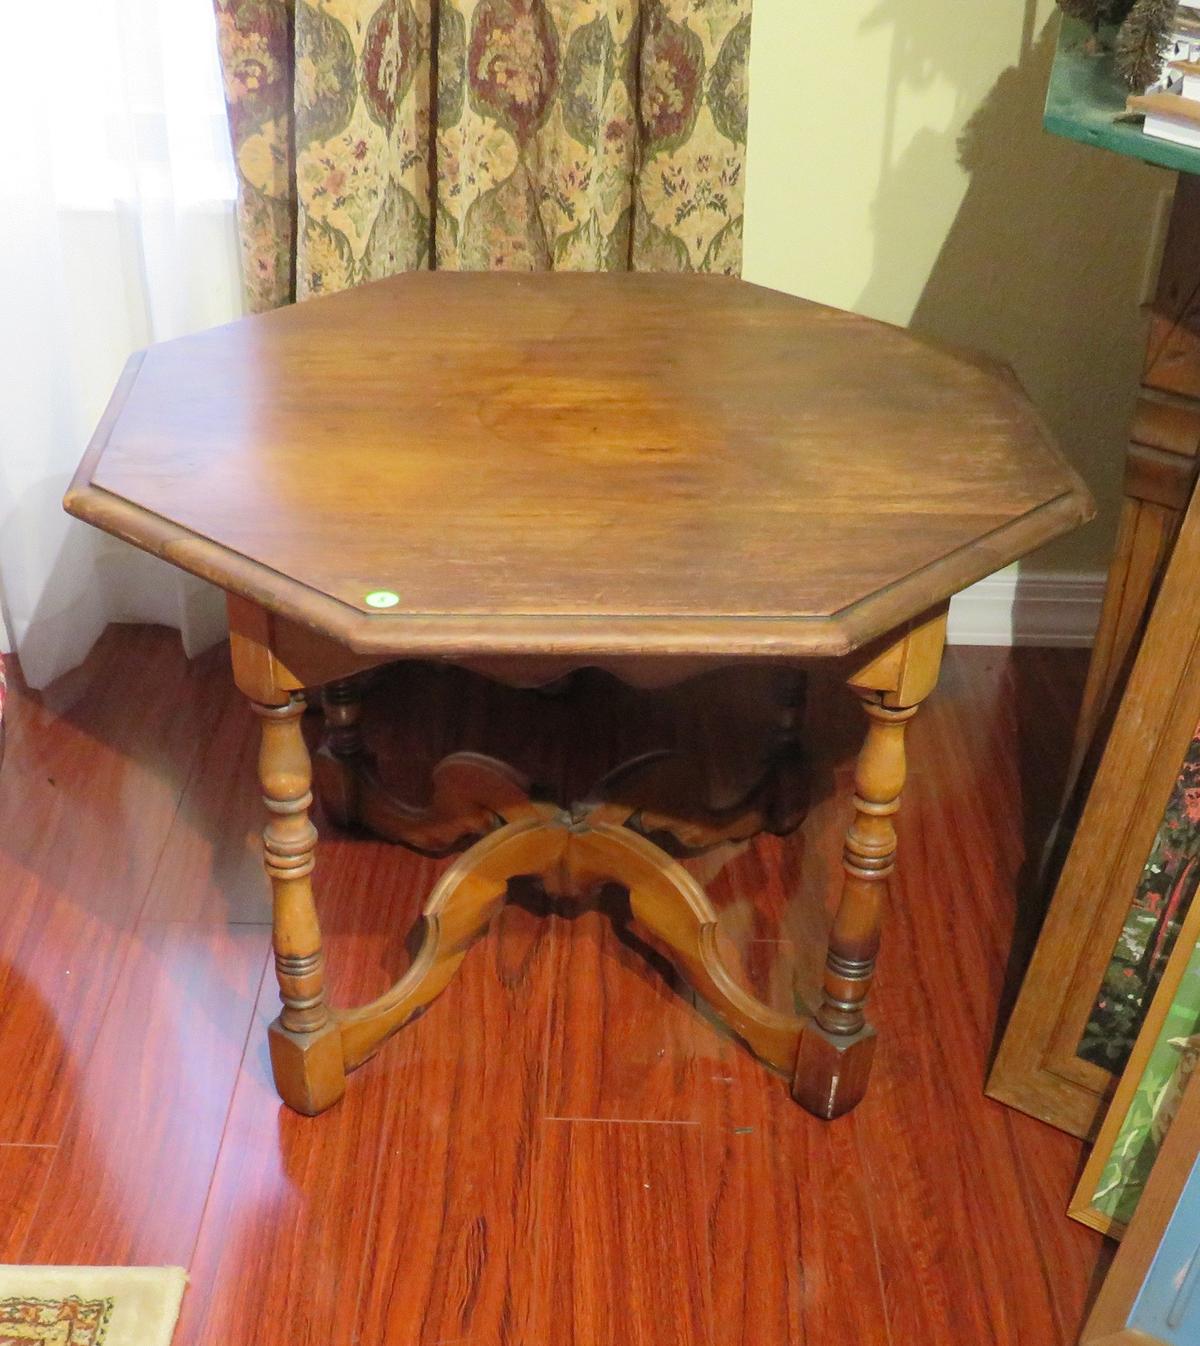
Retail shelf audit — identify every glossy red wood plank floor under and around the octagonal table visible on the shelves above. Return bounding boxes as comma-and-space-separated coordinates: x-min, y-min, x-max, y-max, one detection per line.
0, 627, 1104, 1346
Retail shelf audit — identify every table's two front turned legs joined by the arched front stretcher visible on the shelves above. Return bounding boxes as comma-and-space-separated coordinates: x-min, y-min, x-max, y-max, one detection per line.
243, 670, 916, 1119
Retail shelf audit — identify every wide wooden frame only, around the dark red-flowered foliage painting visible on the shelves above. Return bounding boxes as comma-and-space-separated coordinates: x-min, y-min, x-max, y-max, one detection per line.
987, 484, 1200, 1139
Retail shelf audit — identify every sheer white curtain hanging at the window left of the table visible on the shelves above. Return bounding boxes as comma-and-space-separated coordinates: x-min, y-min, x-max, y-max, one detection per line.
0, 0, 241, 686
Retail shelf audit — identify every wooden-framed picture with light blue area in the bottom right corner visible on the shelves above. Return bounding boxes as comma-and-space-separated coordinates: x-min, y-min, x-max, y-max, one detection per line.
1079, 1078, 1200, 1346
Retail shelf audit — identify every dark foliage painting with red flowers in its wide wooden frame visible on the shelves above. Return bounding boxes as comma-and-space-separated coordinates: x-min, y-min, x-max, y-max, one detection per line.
987, 484, 1200, 1139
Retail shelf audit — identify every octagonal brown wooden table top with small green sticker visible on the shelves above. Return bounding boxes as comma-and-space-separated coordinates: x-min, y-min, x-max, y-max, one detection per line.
66, 272, 1091, 657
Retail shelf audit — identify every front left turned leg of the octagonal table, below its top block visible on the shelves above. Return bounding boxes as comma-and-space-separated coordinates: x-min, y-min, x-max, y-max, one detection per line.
254, 693, 346, 1116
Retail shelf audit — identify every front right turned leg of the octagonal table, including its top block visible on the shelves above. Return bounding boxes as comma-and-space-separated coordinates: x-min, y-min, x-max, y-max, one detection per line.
792, 612, 946, 1117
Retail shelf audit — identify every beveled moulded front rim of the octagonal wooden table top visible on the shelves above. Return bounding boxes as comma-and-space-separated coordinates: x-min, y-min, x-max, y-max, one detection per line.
63, 351, 1095, 660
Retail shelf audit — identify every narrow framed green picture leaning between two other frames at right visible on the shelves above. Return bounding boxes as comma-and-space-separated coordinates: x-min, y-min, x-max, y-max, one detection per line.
1070, 902, 1200, 1238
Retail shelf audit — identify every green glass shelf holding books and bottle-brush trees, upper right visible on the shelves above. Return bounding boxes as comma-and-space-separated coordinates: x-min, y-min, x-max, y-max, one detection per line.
1045, 16, 1200, 174
